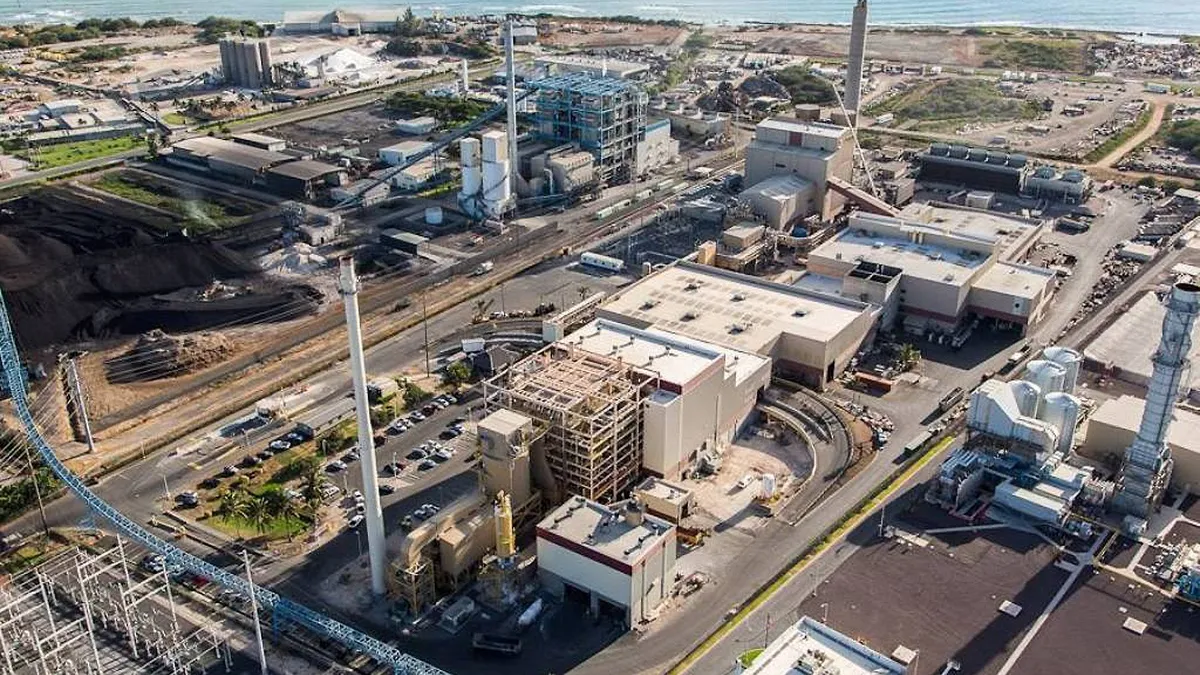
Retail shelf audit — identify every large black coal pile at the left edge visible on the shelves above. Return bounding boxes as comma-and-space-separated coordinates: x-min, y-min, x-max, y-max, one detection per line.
0, 186, 317, 350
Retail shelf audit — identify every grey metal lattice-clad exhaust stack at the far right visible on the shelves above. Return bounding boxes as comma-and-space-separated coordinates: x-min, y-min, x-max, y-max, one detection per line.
1112, 283, 1200, 519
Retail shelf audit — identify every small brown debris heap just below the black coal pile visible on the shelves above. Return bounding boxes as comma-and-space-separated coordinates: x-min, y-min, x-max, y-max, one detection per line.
104, 330, 233, 383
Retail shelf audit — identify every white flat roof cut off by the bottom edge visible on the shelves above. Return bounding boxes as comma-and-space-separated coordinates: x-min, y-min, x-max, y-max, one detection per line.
743, 616, 907, 675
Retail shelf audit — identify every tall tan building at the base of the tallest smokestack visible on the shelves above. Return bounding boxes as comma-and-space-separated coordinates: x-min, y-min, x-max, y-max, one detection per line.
745, 118, 854, 219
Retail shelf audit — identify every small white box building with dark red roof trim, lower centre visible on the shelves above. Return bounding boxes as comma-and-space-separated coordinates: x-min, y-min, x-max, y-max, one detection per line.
538, 496, 676, 626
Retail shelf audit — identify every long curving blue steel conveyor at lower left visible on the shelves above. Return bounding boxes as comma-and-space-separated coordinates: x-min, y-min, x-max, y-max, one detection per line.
0, 289, 449, 675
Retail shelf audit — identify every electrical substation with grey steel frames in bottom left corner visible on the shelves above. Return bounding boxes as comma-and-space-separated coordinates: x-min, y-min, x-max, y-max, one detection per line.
0, 539, 232, 675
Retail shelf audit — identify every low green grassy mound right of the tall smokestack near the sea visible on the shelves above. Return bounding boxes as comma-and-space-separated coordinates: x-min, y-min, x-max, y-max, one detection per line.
870, 79, 1042, 130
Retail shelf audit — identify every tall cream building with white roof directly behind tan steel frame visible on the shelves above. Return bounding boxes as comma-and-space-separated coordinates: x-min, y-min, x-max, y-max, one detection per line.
559, 319, 770, 479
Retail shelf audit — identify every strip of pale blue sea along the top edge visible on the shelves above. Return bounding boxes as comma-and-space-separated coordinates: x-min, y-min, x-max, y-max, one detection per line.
0, 0, 1200, 37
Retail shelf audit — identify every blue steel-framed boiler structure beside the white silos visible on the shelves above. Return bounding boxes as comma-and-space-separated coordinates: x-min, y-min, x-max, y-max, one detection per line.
530, 73, 649, 184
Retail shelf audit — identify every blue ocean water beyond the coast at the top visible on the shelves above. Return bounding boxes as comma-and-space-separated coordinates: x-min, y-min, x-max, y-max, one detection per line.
0, 0, 1200, 34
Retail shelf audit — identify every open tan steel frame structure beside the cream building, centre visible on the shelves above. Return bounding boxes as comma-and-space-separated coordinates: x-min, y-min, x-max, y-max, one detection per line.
484, 345, 642, 502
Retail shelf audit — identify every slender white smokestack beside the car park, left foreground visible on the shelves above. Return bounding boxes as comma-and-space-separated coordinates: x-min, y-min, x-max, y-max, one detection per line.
338, 257, 388, 596
